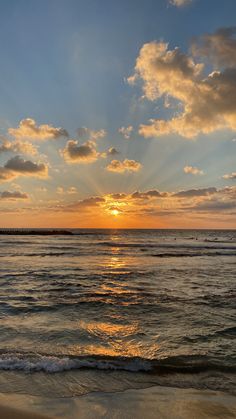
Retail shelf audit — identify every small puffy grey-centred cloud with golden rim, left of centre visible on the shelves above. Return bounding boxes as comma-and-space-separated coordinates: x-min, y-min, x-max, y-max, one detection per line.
61, 140, 99, 163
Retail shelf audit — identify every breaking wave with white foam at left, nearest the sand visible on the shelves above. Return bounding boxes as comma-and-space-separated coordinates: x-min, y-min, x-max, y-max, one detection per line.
0, 353, 236, 375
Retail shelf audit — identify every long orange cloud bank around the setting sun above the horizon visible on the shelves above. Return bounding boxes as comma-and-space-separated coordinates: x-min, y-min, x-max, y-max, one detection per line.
46, 186, 236, 227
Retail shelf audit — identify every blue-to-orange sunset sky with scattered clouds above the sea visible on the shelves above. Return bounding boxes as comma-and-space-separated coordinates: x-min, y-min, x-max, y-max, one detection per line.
0, 0, 236, 229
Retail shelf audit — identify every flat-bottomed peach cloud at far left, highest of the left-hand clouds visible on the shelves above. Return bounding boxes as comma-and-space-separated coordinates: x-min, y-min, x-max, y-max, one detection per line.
8, 118, 68, 141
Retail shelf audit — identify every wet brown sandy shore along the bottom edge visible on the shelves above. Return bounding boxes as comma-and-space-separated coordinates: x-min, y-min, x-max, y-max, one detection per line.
0, 387, 236, 419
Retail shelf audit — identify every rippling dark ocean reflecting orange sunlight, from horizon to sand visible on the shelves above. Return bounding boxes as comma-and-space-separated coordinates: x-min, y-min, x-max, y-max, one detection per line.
0, 229, 236, 398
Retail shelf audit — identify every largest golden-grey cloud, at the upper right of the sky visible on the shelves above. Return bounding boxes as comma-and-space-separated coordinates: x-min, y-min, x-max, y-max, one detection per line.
128, 30, 236, 138
